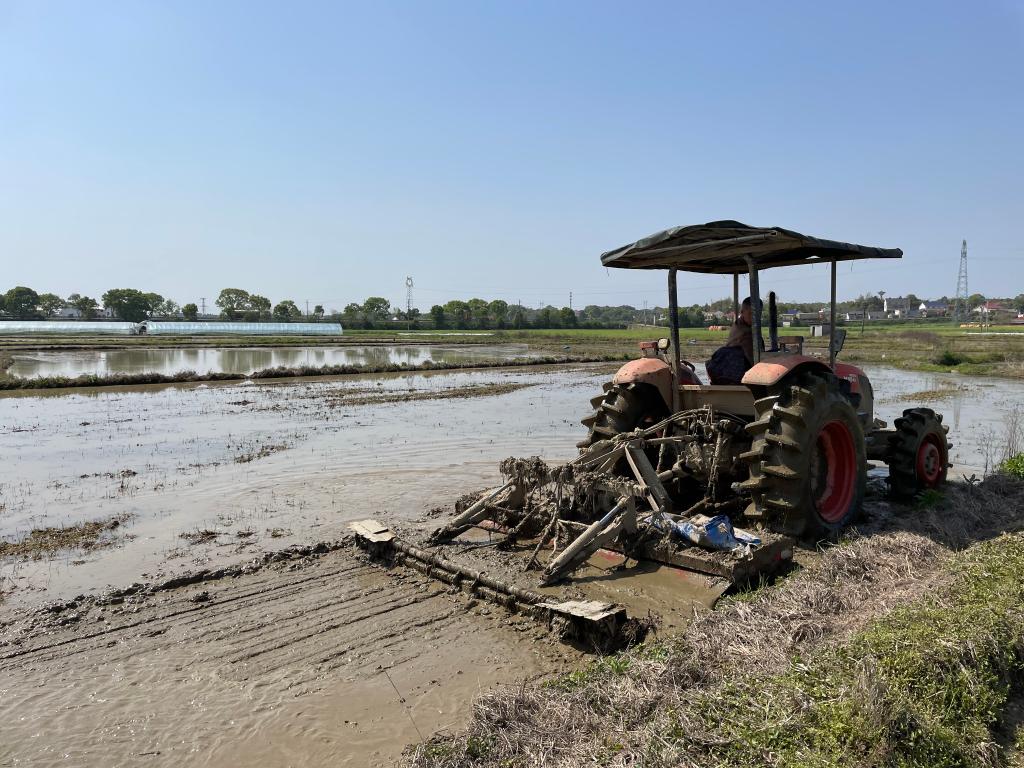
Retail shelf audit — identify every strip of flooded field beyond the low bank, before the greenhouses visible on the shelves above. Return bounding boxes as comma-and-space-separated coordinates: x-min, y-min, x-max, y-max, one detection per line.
8, 344, 531, 378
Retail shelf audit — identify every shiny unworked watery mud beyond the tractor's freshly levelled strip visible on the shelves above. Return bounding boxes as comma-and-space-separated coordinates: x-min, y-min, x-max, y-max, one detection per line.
0, 367, 1024, 601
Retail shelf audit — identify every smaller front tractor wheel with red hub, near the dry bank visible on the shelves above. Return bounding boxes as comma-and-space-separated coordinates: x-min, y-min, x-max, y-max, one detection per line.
886, 408, 951, 501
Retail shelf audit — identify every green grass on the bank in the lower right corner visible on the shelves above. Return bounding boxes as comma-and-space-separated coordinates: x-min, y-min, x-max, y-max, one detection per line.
678, 536, 1024, 768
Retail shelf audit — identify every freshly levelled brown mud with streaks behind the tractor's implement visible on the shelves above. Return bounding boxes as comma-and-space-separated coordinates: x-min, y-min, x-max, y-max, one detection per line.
0, 547, 573, 766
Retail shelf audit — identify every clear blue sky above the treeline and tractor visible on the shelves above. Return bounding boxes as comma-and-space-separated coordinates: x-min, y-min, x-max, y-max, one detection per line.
0, 0, 1024, 309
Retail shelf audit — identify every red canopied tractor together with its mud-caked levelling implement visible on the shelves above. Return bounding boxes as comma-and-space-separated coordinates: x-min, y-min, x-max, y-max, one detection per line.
353, 221, 950, 646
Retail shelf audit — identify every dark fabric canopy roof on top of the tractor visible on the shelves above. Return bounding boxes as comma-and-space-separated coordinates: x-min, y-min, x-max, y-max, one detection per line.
601, 221, 903, 274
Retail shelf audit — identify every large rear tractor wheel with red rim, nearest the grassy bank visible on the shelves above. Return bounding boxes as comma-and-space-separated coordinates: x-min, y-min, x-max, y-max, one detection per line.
740, 372, 867, 536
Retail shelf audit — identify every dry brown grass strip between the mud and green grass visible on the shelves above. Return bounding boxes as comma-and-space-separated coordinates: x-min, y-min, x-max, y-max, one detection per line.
410, 476, 1024, 768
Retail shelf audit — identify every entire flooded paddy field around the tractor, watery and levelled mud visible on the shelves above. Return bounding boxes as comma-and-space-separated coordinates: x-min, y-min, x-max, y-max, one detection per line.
0, 365, 1024, 766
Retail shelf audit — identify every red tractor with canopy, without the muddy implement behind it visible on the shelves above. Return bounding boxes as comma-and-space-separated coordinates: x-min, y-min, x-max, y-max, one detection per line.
581, 221, 949, 536
